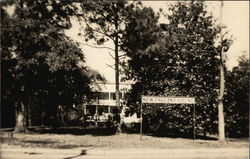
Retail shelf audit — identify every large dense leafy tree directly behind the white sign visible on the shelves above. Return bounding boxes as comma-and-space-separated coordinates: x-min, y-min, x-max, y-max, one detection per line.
122, 1, 231, 137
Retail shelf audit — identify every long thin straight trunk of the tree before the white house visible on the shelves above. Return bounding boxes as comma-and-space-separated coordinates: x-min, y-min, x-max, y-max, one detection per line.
115, 11, 121, 134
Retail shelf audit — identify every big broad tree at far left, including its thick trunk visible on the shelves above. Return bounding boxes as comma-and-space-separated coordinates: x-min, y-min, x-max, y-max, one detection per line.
1, 0, 100, 132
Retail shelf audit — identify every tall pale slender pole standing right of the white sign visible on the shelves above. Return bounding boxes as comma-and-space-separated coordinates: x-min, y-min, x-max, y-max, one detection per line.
218, 1, 225, 142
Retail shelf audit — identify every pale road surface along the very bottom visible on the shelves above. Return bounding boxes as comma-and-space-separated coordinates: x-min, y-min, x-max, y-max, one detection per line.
1, 148, 249, 159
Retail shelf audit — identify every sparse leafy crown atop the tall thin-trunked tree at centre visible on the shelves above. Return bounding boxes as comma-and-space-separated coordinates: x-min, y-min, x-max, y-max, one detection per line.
81, 0, 146, 76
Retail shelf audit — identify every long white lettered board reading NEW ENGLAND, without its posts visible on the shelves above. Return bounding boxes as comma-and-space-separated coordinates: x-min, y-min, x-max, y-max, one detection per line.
142, 96, 195, 104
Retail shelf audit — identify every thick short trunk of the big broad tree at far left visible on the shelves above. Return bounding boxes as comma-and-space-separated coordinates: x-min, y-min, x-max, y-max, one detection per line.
14, 101, 28, 133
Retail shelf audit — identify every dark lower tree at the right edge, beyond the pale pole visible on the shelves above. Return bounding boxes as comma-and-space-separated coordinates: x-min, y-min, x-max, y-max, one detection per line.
224, 55, 250, 137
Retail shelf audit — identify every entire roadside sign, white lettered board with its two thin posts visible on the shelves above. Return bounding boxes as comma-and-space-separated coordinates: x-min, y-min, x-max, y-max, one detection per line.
140, 96, 195, 140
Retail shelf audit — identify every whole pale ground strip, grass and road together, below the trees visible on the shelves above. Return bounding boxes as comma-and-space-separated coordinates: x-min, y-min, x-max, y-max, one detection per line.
0, 131, 249, 159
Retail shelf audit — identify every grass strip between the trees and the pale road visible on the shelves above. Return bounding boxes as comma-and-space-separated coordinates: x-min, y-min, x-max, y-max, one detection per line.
0, 128, 249, 149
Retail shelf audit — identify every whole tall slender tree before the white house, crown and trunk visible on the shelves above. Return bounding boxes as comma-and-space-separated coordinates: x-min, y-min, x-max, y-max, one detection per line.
81, 0, 143, 133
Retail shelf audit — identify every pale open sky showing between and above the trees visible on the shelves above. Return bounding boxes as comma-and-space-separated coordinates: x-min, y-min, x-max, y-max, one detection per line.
66, 1, 249, 82
